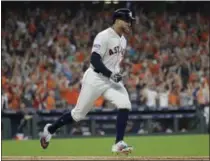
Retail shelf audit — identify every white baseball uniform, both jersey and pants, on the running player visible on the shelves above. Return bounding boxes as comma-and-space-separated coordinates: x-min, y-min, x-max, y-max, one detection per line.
71, 28, 131, 121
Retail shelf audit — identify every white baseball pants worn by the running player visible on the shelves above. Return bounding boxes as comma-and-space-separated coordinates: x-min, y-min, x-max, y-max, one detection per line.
71, 68, 131, 122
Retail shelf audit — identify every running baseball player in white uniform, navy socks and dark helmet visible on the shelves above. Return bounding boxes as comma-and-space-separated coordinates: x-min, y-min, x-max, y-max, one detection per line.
40, 8, 135, 153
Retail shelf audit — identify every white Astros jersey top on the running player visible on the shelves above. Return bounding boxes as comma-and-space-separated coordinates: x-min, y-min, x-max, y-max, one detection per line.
91, 27, 127, 73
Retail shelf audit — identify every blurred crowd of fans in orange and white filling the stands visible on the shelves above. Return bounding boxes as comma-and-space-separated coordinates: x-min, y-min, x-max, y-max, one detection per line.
1, 3, 210, 110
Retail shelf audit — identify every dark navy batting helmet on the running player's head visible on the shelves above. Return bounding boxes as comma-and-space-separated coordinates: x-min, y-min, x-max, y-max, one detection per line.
113, 8, 135, 23
